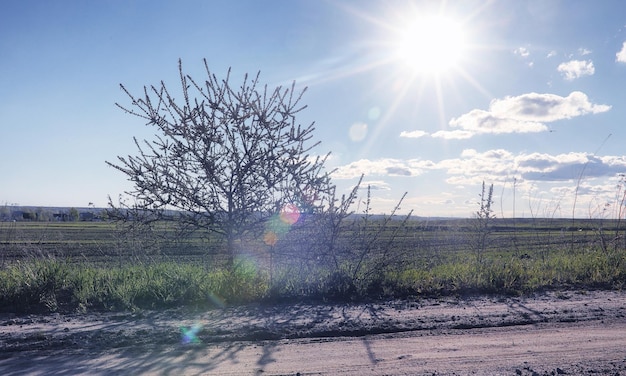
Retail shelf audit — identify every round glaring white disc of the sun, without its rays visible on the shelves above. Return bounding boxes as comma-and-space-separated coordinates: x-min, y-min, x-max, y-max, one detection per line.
396, 16, 466, 75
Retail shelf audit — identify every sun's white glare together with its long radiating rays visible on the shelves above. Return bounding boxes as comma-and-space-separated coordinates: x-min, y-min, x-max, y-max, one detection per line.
297, 0, 492, 164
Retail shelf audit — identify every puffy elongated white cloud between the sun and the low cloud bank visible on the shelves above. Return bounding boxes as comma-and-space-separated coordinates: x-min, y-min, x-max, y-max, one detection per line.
444, 91, 611, 139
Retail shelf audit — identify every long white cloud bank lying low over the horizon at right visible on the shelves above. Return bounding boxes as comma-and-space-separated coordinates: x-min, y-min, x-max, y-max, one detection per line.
332, 149, 626, 216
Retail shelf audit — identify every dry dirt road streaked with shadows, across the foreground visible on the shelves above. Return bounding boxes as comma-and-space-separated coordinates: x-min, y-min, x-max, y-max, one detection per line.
0, 291, 626, 375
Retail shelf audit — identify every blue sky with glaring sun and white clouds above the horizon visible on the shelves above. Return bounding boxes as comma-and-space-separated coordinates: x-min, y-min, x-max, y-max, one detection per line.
0, 0, 626, 218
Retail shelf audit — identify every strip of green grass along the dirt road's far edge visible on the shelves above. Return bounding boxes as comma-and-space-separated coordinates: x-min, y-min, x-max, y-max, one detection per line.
0, 245, 626, 312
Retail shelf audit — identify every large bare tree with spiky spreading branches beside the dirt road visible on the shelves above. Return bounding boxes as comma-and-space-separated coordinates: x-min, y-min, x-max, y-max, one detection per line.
107, 60, 331, 265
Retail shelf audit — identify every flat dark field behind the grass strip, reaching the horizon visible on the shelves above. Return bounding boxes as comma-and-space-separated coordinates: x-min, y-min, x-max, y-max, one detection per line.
0, 219, 626, 263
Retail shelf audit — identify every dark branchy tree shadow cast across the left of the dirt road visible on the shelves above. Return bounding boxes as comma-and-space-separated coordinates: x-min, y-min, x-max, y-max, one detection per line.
0, 304, 342, 375
